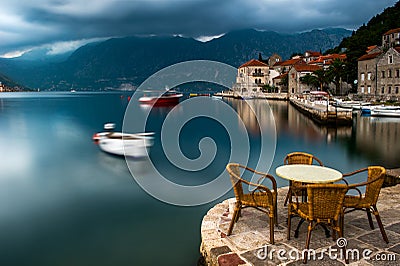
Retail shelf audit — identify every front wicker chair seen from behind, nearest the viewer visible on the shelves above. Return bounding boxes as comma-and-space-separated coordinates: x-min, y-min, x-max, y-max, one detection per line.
287, 184, 348, 263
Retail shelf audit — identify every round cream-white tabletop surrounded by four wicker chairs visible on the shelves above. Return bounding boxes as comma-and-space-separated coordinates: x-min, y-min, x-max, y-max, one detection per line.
276, 164, 342, 183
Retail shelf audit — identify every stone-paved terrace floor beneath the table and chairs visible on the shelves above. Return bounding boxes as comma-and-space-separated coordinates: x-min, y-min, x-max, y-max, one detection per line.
200, 185, 400, 266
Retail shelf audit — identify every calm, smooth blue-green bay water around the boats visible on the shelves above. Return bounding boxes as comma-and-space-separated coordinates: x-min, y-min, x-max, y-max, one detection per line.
0, 92, 400, 266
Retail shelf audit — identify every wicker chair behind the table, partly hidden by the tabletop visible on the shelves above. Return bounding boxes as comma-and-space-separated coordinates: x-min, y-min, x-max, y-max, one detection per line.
283, 152, 324, 206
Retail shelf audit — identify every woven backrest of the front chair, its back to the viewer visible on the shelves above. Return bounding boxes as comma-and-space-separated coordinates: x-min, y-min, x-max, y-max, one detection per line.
307, 184, 348, 220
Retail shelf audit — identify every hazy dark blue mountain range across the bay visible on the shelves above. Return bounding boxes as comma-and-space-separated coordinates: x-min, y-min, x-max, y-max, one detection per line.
0, 28, 352, 90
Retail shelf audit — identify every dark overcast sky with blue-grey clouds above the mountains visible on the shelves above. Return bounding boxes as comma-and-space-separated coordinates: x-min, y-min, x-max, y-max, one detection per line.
0, 0, 397, 57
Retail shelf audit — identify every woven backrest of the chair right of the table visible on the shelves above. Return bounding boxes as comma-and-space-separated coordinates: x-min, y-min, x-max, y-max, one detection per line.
364, 166, 386, 204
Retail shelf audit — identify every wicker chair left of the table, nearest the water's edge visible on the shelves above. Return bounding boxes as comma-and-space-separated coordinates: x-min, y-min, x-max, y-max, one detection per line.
226, 163, 278, 244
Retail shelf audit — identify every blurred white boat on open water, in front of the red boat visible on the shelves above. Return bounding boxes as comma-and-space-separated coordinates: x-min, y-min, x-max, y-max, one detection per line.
93, 123, 154, 158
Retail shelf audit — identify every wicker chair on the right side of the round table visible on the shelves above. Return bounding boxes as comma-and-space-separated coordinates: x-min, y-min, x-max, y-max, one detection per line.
342, 166, 389, 243
